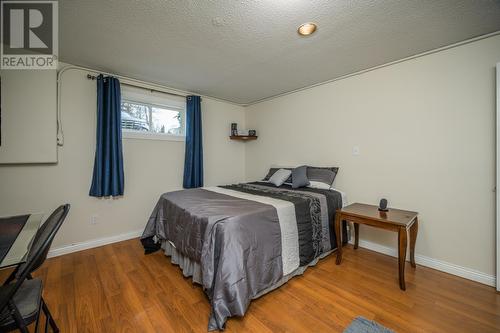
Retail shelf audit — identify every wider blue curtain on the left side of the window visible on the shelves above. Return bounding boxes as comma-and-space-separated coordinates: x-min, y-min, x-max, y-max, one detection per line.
89, 75, 124, 197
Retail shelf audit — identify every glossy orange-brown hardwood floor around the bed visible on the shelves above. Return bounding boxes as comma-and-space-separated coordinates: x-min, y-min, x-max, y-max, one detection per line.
29, 239, 500, 333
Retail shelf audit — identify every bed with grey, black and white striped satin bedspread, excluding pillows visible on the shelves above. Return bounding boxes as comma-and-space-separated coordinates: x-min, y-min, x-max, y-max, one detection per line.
141, 181, 347, 330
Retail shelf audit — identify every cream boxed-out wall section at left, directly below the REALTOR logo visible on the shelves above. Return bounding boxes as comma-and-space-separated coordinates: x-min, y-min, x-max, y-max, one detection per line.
0, 70, 57, 163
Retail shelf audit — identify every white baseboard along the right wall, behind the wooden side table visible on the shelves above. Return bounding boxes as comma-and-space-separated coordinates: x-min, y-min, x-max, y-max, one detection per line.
349, 239, 496, 287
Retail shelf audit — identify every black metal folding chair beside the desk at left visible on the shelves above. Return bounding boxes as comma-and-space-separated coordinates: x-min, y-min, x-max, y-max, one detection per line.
0, 204, 70, 332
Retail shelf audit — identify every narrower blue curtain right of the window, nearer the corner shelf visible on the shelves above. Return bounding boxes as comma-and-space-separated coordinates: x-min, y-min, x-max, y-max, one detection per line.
184, 96, 203, 188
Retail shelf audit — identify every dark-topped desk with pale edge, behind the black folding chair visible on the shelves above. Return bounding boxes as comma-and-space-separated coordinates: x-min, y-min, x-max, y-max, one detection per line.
0, 214, 43, 269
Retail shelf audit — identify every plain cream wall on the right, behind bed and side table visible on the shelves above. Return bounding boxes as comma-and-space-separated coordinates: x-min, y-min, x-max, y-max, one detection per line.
246, 35, 500, 275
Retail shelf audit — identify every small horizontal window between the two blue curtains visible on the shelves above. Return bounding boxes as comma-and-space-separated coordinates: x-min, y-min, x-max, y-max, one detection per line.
121, 87, 185, 140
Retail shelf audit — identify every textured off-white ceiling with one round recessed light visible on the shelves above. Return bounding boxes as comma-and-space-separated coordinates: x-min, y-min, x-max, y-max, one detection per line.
59, 0, 500, 104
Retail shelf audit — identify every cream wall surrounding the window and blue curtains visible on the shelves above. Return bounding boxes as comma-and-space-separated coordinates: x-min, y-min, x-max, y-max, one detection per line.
0, 66, 245, 248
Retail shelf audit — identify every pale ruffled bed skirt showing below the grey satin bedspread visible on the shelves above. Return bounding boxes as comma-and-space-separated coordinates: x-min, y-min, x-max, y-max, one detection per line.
161, 241, 335, 299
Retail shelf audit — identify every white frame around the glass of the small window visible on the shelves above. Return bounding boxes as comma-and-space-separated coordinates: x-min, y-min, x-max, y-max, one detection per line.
120, 94, 186, 141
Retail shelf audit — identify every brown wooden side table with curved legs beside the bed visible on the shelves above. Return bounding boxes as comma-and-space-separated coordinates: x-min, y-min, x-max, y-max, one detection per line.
335, 203, 418, 290
